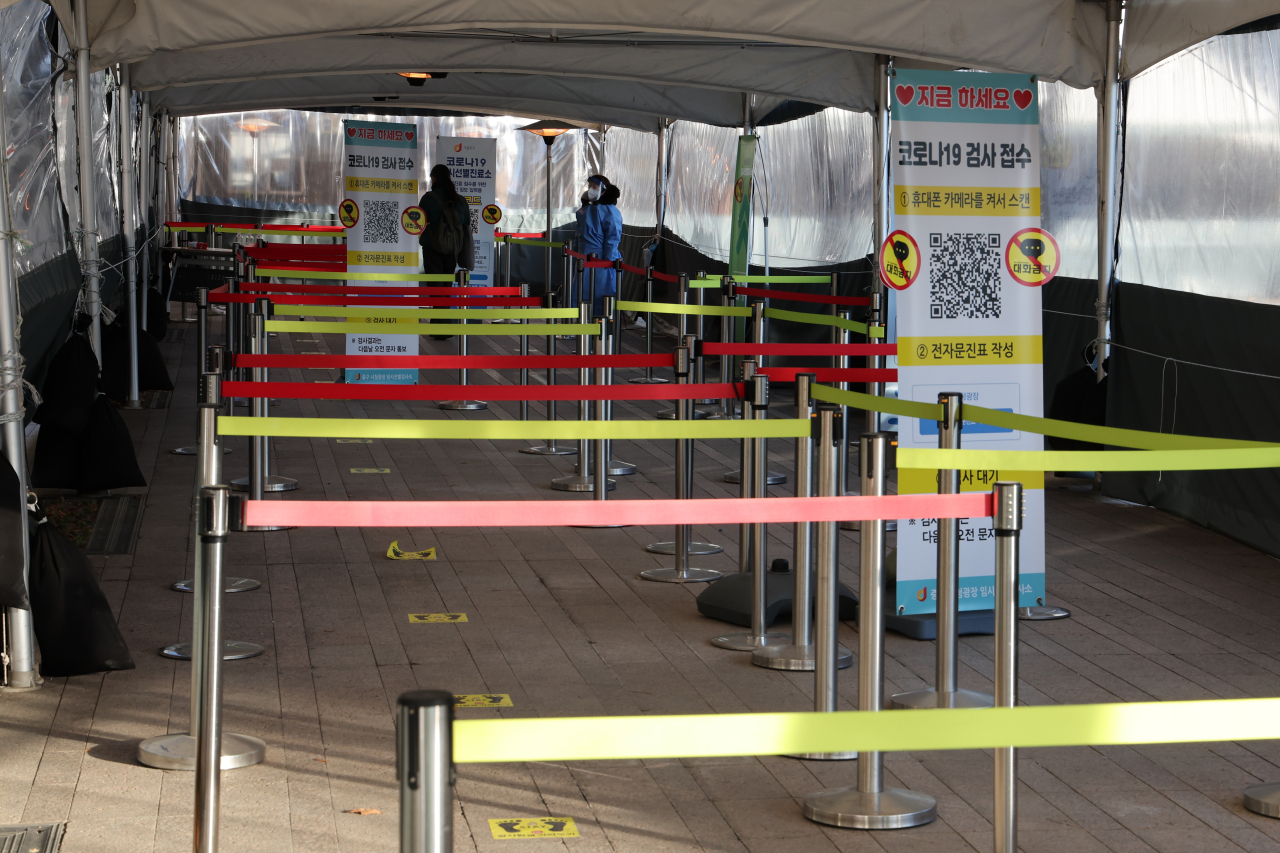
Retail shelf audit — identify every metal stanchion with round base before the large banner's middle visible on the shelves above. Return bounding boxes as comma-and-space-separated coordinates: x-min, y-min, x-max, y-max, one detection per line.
890, 392, 1000, 708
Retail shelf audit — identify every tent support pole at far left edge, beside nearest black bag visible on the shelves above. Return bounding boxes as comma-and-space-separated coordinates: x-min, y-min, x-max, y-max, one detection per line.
0, 51, 40, 690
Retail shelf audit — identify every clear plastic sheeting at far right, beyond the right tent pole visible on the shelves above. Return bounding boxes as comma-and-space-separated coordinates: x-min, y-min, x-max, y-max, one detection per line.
1119, 32, 1280, 302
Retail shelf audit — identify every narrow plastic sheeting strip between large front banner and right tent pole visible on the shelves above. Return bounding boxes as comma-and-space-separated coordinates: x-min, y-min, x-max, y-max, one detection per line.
1039, 83, 1098, 280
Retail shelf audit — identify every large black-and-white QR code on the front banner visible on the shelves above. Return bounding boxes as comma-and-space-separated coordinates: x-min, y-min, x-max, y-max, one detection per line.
929, 234, 1001, 320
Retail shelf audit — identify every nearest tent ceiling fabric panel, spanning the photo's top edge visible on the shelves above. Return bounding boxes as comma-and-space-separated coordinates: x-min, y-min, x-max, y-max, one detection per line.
64, 0, 1106, 86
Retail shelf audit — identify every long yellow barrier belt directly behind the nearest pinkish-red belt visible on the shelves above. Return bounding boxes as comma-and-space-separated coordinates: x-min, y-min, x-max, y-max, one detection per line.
218, 412, 810, 438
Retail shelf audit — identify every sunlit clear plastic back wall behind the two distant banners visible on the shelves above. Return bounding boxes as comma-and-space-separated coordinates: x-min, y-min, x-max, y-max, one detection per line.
178, 110, 590, 231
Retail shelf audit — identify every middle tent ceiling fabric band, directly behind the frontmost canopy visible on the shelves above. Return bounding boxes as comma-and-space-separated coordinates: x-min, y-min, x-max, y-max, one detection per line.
131, 33, 876, 118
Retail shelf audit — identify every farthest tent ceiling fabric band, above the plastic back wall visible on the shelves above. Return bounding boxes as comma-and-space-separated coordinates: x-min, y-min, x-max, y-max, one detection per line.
142, 73, 783, 132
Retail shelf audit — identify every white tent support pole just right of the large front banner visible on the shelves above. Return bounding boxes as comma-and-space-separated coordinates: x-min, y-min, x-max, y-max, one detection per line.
1093, 0, 1120, 382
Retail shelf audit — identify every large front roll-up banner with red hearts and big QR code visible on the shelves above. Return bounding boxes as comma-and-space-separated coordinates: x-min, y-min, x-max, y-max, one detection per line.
879, 69, 1059, 615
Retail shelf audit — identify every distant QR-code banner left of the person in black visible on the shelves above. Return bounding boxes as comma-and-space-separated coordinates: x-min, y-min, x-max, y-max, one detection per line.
338, 119, 426, 386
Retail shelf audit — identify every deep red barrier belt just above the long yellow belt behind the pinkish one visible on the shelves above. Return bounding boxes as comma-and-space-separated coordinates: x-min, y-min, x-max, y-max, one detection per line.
223, 381, 742, 401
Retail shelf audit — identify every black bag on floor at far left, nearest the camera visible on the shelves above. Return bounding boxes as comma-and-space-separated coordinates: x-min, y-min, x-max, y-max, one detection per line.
27, 502, 133, 678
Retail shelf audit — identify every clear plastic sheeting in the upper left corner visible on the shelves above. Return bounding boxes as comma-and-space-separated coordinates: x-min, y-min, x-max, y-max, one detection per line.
0, 0, 67, 275
